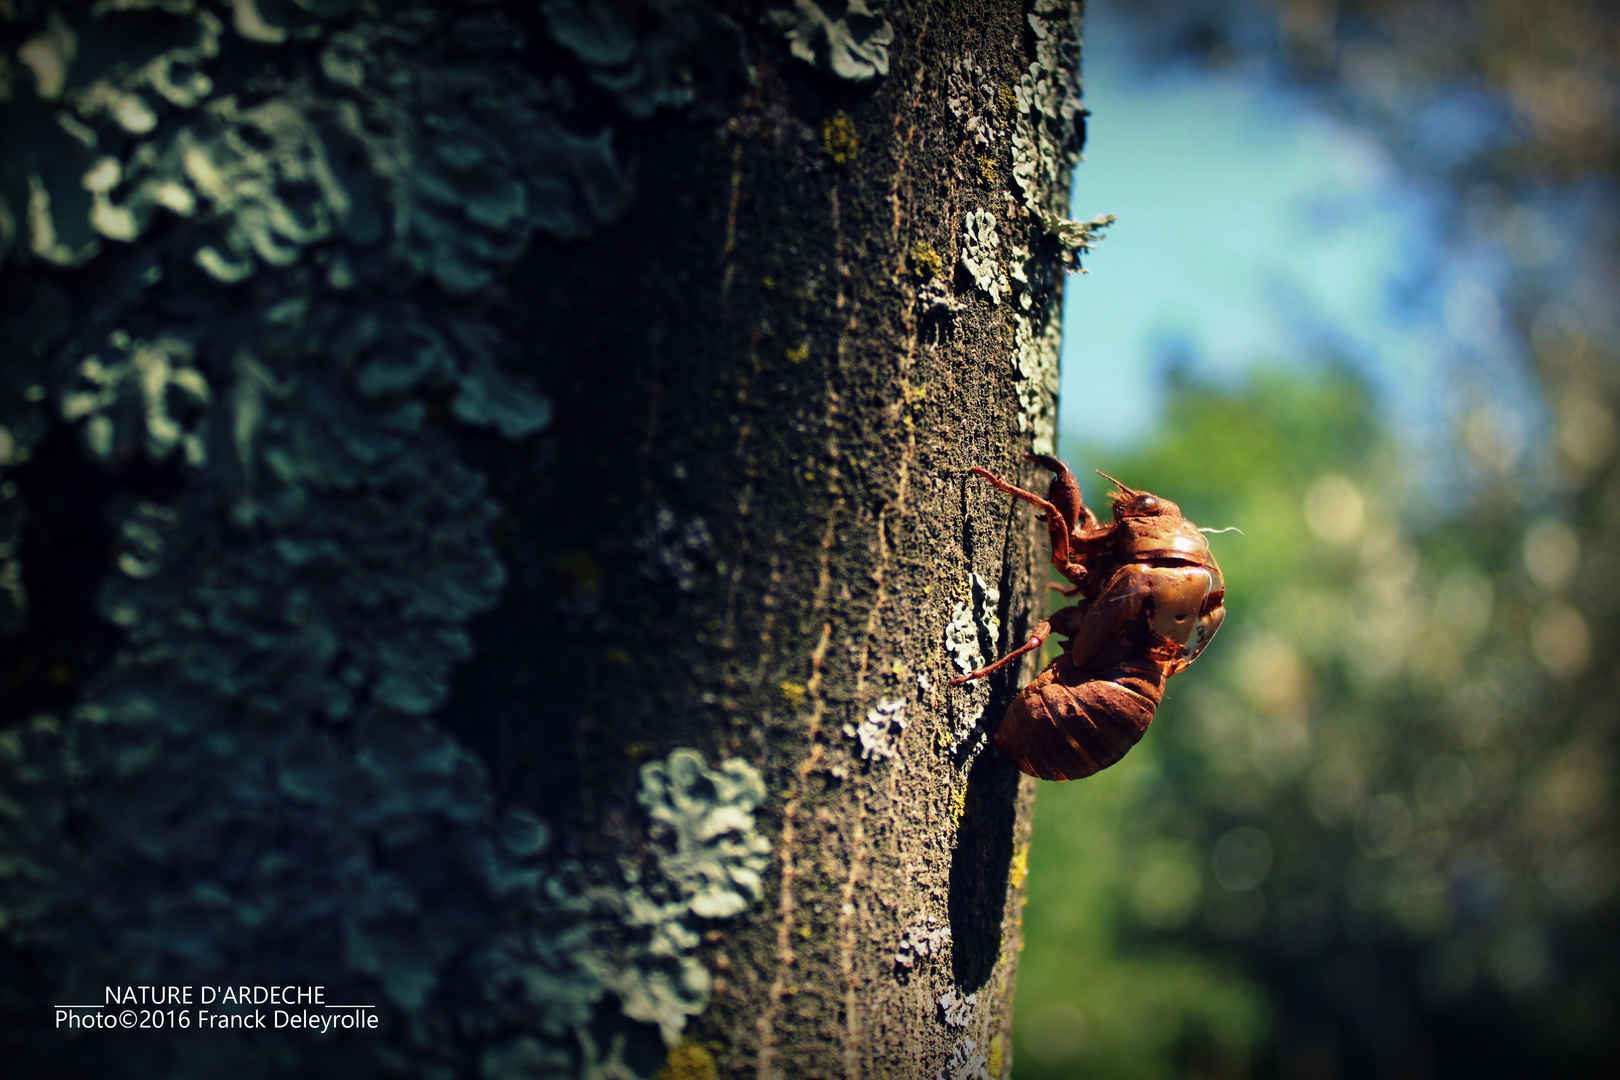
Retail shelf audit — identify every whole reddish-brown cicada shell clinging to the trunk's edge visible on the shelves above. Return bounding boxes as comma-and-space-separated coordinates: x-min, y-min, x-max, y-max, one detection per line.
951, 453, 1226, 780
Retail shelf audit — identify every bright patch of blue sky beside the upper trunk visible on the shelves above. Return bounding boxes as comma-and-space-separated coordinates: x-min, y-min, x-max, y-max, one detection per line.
1059, 5, 1529, 450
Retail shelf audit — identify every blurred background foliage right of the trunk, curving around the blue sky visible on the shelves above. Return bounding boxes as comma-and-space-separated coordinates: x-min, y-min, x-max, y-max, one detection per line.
1014, 0, 1620, 1080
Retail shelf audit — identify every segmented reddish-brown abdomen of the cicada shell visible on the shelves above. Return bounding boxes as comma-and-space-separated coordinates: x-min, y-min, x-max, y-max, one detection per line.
993, 654, 1165, 780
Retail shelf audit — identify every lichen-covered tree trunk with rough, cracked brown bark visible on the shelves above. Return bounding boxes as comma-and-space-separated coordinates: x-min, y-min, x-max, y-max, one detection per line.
0, 0, 1085, 1080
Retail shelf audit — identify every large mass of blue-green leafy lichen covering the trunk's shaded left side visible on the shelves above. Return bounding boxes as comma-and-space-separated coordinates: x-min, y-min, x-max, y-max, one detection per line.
0, 0, 768, 1077
